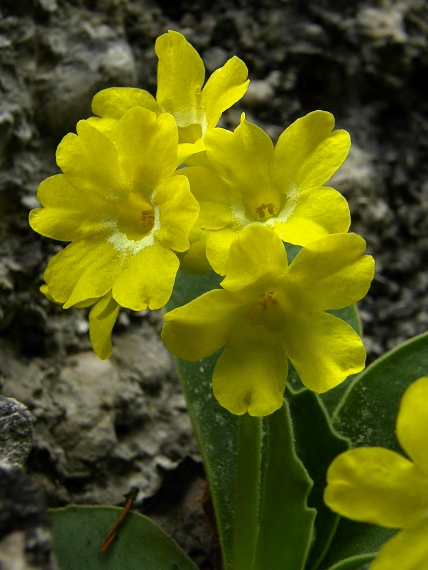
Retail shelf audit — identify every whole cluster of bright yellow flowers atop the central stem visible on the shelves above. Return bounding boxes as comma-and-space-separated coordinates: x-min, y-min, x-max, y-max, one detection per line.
30, 31, 374, 416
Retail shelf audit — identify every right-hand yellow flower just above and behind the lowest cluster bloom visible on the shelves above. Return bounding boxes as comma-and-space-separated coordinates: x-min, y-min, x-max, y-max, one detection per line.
180, 111, 350, 275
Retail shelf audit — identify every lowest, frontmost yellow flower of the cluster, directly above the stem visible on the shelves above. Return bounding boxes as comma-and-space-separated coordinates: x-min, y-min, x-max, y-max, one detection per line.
162, 225, 374, 416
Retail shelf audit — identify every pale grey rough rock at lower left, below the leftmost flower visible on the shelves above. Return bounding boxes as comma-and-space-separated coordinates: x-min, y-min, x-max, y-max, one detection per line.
0, 325, 197, 506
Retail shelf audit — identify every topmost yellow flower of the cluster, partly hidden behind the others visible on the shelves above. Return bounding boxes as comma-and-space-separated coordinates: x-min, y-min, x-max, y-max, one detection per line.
90, 31, 248, 163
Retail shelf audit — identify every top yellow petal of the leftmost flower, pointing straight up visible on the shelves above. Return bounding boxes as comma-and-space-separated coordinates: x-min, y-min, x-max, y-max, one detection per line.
115, 107, 178, 192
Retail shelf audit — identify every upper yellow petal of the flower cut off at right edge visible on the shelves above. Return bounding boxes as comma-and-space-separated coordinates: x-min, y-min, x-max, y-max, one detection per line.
397, 376, 428, 475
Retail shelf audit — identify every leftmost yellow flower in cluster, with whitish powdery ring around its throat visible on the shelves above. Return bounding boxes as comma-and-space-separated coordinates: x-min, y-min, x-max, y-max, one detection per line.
30, 107, 199, 352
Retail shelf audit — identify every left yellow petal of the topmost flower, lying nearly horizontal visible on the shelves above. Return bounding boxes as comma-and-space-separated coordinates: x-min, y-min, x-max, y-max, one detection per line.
92, 87, 161, 120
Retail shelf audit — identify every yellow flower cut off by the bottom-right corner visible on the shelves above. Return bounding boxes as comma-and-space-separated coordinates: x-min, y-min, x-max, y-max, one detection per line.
324, 377, 428, 570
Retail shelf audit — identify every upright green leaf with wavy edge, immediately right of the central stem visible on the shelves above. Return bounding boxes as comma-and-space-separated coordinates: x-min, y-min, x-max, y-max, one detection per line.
254, 401, 316, 570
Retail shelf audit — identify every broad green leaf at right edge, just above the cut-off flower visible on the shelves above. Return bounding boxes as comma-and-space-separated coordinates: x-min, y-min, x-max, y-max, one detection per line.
333, 333, 428, 451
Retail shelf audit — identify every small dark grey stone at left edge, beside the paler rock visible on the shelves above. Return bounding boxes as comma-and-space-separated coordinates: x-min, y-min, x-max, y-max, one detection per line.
0, 396, 33, 465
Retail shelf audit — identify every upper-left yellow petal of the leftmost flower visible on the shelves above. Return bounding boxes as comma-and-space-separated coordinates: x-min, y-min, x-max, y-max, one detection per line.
56, 121, 124, 197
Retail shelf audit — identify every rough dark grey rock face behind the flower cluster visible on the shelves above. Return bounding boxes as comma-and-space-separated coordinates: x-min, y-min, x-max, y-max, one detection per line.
0, 0, 428, 568
